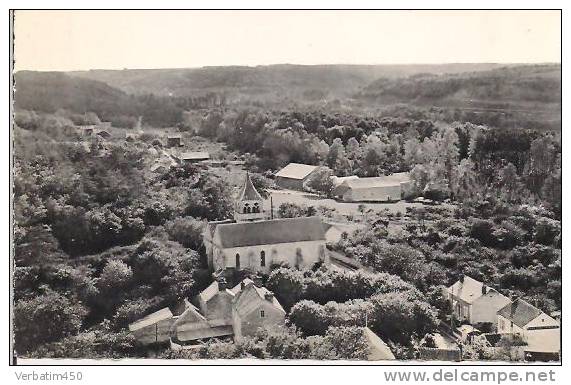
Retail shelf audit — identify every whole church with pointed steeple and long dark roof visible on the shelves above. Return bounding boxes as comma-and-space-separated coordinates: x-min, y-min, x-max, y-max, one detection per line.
203, 175, 329, 272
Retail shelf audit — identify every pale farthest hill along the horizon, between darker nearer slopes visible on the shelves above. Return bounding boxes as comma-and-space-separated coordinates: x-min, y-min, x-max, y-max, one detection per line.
68, 64, 510, 99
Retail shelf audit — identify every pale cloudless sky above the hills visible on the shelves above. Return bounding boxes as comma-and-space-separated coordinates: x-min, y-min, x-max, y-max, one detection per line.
14, 10, 561, 71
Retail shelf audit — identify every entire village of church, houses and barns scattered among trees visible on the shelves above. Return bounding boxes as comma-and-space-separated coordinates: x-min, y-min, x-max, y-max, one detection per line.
75, 121, 561, 361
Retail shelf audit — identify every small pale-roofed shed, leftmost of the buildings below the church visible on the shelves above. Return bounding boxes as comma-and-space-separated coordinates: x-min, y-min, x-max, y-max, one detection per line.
129, 307, 175, 344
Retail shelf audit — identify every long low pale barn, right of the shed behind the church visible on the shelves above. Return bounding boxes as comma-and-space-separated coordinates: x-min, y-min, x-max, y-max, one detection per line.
333, 172, 410, 202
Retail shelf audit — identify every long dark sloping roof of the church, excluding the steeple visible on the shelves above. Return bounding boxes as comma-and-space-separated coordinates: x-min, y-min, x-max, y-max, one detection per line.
215, 217, 325, 248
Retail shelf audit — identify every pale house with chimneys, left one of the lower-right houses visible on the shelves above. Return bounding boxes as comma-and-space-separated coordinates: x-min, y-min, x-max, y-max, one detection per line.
445, 276, 510, 326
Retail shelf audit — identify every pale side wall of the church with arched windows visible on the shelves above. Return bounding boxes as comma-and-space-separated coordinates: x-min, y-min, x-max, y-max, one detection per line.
214, 240, 329, 272
